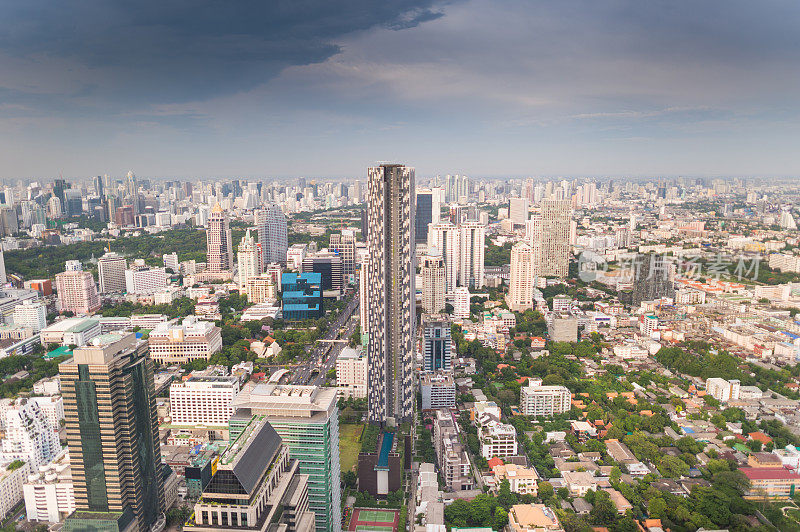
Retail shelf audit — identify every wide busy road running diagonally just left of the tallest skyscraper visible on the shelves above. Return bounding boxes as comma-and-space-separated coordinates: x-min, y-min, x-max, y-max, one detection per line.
292, 290, 358, 386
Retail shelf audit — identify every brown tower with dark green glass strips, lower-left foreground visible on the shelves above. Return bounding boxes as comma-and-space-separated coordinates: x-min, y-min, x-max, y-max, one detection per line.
59, 333, 165, 532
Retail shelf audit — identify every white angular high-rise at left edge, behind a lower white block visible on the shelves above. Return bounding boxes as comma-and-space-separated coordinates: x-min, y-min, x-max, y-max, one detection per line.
0, 398, 61, 469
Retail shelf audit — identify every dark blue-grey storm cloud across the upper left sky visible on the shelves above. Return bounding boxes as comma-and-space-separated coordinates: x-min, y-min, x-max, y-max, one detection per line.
0, 0, 450, 103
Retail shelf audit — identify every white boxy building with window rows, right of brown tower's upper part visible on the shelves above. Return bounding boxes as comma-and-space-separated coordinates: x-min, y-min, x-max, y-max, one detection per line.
169, 376, 239, 427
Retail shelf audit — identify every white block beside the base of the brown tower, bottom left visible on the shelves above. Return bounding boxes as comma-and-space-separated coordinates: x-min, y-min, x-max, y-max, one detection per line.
22, 449, 75, 523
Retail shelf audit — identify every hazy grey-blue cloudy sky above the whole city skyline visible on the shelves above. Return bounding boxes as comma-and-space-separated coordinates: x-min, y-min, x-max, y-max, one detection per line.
0, 0, 800, 179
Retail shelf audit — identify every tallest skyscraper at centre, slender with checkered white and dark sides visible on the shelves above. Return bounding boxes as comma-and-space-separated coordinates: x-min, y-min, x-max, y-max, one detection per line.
367, 164, 416, 423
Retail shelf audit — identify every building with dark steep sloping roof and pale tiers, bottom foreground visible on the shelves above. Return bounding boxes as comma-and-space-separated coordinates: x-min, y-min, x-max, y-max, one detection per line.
188, 416, 314, 532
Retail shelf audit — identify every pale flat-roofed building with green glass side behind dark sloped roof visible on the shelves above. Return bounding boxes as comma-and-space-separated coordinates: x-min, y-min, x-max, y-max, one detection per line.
229, 383, 342, 532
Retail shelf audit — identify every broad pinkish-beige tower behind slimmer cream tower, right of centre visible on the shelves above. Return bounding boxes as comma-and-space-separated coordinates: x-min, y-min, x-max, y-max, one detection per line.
537, 200, 572, 277
